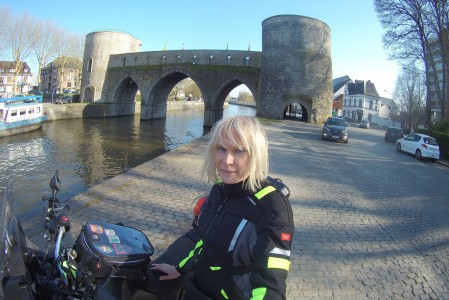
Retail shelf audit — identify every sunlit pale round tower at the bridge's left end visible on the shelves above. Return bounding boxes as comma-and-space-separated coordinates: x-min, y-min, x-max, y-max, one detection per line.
80, 31, 142, 102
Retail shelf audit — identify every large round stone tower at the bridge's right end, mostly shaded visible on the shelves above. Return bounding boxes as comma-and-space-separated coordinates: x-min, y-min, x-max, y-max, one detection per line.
257, 15, 333, 123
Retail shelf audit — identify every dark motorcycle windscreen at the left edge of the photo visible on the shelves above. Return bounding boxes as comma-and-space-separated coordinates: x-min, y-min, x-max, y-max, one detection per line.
0, 183, 26, 281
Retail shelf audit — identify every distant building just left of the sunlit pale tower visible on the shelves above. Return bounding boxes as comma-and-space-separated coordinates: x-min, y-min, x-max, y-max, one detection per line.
39, 57, 82, 93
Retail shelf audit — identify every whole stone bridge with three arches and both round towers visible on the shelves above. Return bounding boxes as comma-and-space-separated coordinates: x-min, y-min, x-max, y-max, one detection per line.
81, 15, 333, 127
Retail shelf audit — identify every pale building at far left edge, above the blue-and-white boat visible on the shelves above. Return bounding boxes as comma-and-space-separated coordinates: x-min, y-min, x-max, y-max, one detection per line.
0, 61, 33, 97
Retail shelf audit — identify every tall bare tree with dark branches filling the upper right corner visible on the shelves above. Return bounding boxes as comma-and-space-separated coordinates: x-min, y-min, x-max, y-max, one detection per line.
374, 0, 448, 125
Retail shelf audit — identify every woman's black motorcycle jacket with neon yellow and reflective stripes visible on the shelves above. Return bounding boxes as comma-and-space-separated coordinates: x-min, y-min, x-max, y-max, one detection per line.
176, 178, 294, 299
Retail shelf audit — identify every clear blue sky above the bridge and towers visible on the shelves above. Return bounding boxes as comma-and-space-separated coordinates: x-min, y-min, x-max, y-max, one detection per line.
0, 0, 399, 97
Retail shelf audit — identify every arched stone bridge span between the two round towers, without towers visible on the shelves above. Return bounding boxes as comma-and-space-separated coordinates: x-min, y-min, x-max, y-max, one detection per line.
102, 50, 261, 126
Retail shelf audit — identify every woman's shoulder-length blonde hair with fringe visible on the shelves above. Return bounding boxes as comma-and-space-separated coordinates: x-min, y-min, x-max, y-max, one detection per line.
203, 116, 268, 193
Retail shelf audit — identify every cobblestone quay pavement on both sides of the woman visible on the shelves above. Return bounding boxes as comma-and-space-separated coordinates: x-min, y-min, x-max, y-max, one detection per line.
26, 121, 449, 300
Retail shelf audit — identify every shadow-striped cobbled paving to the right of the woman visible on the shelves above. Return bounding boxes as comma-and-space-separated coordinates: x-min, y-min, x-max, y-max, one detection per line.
271, 123, 449, 299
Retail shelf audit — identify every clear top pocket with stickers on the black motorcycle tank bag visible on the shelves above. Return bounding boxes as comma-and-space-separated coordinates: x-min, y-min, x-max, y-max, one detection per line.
86, 221, 154, 259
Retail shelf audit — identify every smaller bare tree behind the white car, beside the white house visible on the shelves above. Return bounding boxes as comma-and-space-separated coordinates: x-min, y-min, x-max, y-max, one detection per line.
394, 65, 426, 129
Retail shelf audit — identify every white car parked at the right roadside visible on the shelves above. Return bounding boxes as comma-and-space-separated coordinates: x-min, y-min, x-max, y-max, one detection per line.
396, 133, 440, 161
